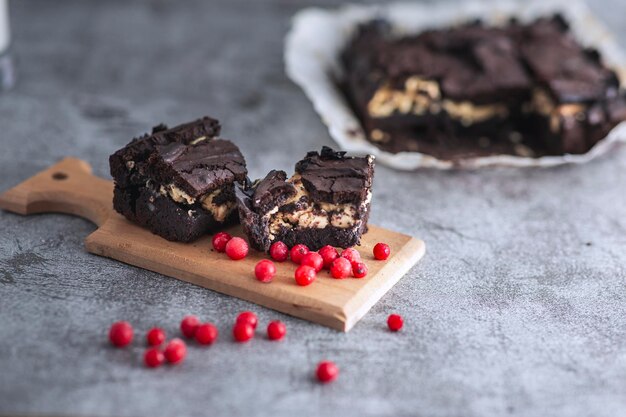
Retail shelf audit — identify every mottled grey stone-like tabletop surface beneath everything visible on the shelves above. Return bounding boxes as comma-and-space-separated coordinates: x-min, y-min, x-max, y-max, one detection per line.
0, 0, 626, 417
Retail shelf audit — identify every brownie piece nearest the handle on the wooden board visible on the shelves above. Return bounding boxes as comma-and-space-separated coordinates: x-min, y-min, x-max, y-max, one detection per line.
109, 117, 247, 242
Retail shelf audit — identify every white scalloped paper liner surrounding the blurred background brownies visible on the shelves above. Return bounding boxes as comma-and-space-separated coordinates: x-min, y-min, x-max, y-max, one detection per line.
285, 0, 626, 170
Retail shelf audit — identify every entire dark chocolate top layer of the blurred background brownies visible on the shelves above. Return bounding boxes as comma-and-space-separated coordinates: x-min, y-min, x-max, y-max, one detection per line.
347, 17, 613, 103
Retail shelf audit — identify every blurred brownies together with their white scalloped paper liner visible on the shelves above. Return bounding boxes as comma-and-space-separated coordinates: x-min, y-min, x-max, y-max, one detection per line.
285, 0, 626, 170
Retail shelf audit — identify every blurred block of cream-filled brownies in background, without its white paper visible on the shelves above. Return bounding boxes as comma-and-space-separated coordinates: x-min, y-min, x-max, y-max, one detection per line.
342, 16, 626, 159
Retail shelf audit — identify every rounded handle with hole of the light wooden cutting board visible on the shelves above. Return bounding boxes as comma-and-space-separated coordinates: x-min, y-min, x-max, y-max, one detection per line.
0, 158, 113, 226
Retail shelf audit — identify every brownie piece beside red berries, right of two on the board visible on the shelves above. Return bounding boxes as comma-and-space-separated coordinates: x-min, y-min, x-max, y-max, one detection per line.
235, 147, 374, 252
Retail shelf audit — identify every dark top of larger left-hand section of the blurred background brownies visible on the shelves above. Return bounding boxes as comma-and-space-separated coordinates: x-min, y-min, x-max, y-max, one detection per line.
370, 25, 530, 103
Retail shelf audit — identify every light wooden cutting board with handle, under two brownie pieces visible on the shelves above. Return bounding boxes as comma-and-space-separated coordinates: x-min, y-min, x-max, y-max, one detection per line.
0, 158, 425, 332
